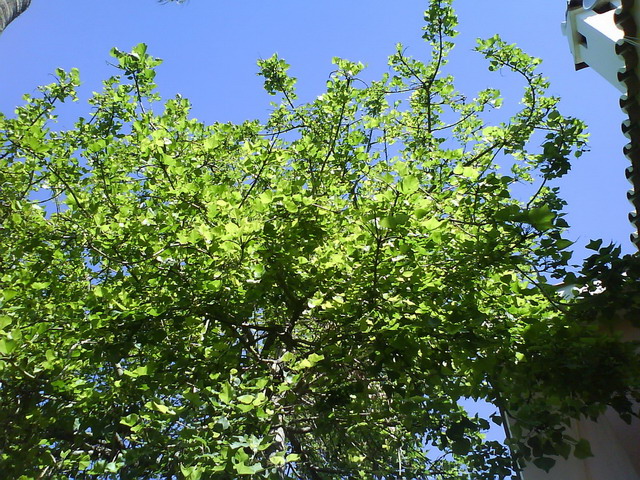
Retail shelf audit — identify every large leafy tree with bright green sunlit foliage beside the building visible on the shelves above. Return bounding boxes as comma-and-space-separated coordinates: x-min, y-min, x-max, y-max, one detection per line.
0, 1, 638, 480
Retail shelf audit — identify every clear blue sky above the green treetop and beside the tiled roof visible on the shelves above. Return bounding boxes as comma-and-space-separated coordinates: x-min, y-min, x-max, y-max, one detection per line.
0, 0, 634, 257
